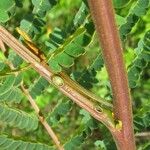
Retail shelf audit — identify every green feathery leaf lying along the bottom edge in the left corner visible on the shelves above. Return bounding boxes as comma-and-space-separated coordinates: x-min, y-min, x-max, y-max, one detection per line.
0, 135, 54, 150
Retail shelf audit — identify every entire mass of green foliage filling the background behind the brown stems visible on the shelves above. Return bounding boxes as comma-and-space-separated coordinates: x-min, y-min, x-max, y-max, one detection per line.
0, 0, 150, 150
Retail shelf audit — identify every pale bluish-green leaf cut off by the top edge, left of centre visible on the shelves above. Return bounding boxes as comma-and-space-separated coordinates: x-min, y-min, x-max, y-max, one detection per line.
32, 0, 57, 17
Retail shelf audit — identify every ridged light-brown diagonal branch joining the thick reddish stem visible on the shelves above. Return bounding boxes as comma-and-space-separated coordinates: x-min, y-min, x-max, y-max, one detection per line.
0, 26, 120, 134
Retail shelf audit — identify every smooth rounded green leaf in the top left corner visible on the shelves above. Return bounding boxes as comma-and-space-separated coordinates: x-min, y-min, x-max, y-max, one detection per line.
0, 0, 15, 23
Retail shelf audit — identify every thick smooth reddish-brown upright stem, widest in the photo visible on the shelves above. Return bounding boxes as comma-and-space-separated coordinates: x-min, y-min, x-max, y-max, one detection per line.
88, 0, 136, 150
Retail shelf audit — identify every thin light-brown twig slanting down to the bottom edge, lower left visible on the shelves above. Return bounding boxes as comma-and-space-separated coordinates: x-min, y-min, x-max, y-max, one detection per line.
21, 85, 64, 150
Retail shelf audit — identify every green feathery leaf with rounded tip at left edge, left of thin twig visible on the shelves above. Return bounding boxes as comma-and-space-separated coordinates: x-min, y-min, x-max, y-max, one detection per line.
0, 104, 38, 131
